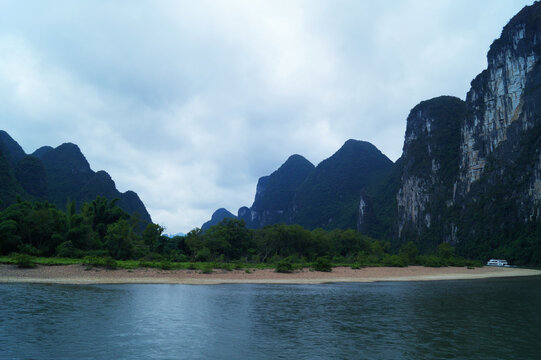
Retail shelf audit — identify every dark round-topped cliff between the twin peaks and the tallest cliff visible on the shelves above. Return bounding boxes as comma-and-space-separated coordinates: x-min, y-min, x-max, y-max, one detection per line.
397, 96, 467, 248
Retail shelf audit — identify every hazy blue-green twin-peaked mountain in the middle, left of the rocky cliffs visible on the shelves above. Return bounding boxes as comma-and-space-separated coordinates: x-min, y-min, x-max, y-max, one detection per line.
206, 139, 393, 229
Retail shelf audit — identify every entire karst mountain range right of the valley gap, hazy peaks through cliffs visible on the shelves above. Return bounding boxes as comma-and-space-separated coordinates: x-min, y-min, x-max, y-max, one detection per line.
202, 2, 541, 262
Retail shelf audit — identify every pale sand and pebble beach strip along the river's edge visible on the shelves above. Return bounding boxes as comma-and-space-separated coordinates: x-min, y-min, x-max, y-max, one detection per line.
0, 265, 541, 285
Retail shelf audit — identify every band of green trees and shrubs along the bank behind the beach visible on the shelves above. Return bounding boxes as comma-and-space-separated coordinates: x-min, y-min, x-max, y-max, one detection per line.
0, 197, 482, 272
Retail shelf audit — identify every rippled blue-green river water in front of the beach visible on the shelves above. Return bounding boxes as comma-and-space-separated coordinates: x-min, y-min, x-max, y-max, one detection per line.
0, 277, 541, 359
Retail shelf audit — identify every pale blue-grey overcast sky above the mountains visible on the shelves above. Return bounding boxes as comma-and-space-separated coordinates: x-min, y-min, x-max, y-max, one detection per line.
0, 0, 532, 233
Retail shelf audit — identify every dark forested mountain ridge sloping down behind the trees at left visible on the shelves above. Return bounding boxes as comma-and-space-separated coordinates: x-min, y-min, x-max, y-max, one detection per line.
0, 130, 151, 223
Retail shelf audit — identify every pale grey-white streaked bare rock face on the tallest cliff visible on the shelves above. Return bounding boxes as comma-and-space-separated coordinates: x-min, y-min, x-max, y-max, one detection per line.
460, 8, 541, 193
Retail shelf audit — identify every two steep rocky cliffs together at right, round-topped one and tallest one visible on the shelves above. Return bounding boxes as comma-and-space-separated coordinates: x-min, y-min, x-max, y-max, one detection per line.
397, 3, 541, 256
